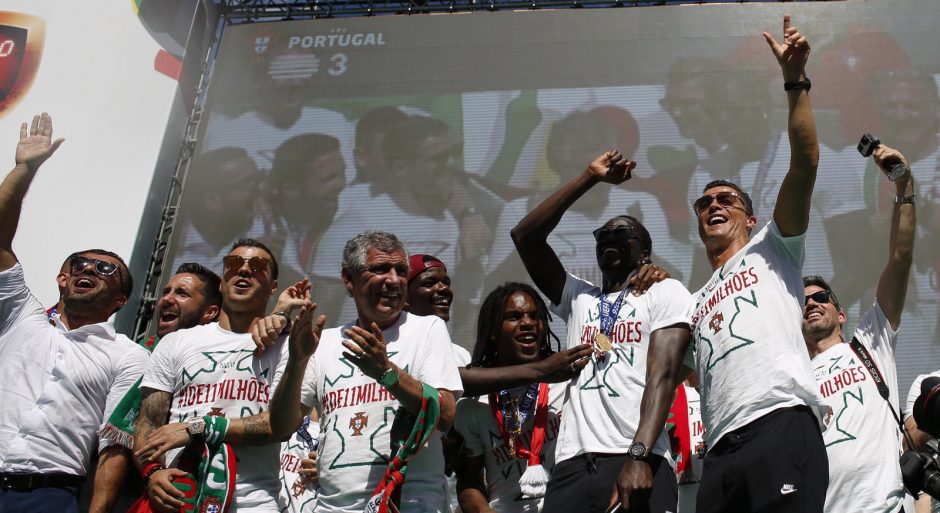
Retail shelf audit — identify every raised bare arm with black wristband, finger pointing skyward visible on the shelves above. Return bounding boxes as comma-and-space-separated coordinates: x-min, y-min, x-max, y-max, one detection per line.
764, 14, 819, 237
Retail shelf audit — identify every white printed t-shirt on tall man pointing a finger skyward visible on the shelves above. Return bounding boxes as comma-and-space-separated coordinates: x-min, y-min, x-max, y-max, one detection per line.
691, 222, 822, 451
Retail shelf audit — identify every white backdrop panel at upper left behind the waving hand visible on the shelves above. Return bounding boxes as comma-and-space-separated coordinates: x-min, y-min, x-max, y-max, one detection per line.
0, 0, 184, 310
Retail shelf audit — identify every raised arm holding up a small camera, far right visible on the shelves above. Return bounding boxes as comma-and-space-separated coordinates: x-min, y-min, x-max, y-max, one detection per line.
872, 144, 916, 330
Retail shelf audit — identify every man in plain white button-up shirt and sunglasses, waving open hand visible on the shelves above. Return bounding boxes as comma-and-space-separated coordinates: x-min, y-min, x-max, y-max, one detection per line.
0, 113, 147, 512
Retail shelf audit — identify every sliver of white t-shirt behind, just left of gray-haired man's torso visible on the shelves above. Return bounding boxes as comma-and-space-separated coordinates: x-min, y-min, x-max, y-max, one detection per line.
280, 420, 320, 513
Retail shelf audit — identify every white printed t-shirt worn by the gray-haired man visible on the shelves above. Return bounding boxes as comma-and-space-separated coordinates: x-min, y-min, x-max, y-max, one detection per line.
301, 312, 463, 513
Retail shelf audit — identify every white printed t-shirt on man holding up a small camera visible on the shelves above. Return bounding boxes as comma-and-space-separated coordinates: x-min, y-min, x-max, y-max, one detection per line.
812, 303, 904, 512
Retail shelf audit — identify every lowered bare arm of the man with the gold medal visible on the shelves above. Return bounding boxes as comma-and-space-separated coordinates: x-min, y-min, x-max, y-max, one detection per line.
610, 324, 692, 510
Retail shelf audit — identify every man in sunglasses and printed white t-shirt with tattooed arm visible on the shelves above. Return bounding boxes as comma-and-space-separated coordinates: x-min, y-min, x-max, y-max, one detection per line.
135, 239, 287, 513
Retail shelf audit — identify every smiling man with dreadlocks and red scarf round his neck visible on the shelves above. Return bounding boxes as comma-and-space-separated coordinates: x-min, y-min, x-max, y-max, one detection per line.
454, 283, 566, 513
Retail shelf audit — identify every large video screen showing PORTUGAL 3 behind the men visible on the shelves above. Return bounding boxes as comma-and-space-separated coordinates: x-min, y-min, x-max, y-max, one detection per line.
164, 0, 940, 390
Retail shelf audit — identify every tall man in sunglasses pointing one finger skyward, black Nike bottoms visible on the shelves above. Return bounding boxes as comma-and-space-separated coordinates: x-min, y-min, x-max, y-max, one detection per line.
691, 15, 828, 513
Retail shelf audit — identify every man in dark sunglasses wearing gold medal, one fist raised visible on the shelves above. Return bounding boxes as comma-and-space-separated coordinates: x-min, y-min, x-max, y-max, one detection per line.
512, 150, 691, 513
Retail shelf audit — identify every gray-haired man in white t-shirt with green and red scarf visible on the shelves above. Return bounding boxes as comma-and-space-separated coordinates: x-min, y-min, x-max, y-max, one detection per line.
271, 231, 462, 513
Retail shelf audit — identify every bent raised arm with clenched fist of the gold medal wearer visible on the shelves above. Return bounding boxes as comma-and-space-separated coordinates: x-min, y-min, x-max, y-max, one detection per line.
510, 150, 636, 304
